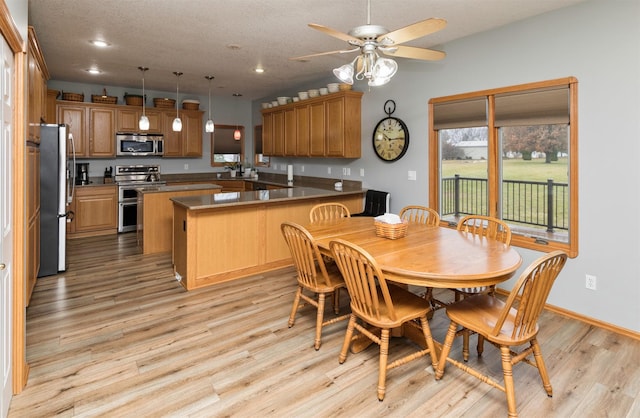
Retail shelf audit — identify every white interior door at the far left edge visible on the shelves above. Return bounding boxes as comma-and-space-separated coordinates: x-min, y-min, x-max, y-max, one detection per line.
0, 34, 13, 417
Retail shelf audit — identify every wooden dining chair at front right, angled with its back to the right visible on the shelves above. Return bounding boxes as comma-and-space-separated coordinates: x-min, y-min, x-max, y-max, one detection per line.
436, 251, 567, 417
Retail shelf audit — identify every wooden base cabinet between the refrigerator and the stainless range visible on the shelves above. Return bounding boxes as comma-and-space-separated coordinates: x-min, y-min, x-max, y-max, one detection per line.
69, 184, 118, 238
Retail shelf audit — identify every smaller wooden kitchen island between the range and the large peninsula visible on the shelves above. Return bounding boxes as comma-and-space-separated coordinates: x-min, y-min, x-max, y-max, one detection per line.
136, 184, 222, 254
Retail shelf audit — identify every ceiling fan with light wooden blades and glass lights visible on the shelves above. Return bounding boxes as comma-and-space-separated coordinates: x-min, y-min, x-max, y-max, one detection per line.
289, 0, 447, 86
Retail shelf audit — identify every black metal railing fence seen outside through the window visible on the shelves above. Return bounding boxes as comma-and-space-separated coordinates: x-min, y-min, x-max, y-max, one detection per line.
441, 174, 569, 232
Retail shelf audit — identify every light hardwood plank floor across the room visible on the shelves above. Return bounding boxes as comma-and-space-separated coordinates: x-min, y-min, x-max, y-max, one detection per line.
9, 234, 640, 417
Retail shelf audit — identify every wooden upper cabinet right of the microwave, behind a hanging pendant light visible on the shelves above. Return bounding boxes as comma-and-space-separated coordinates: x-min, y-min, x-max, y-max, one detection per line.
163, 110, 204, 157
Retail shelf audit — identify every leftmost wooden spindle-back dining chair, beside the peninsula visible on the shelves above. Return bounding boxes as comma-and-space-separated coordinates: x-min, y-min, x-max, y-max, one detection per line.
280, 222, 349, 350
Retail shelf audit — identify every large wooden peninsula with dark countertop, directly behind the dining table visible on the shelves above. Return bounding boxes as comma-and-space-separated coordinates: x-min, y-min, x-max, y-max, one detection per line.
171, 187, 364, 290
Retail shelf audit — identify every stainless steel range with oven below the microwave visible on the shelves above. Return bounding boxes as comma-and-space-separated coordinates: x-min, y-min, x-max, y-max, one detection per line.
114, 165, 166, 232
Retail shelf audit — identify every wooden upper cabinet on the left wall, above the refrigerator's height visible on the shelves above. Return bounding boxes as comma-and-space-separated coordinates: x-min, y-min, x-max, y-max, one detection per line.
27, 26, 53, 144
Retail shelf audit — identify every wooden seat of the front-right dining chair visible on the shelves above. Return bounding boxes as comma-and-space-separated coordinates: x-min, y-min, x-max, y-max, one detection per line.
447, 294, 538, 346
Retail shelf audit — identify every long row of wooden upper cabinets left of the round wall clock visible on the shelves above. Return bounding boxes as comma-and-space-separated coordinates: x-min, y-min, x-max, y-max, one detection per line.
262, 91, 362, 158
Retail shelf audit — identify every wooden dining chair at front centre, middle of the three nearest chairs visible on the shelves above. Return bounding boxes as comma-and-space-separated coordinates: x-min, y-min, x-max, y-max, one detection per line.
329, 239, 437, 400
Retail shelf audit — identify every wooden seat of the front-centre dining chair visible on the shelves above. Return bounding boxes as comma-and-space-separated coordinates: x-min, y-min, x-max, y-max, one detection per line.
351, 282, 431, 329
